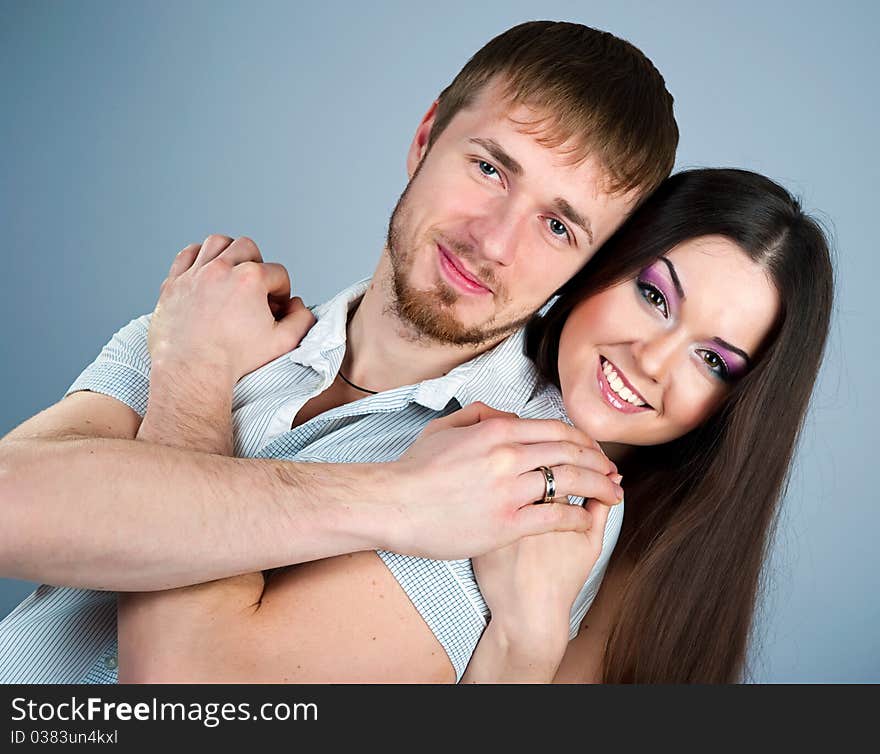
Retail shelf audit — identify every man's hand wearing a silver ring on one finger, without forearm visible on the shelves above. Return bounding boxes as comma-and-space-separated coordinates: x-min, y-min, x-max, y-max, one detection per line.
384, 403, 623, 559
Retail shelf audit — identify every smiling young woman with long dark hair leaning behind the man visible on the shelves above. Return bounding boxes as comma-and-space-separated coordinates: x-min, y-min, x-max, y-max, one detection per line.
463, 170, 833, 683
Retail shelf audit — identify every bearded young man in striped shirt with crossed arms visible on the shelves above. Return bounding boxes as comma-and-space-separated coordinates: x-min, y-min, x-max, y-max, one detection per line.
0, 22, 677, 681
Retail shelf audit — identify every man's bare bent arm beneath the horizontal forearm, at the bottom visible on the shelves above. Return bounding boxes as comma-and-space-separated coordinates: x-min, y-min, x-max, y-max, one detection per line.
119, 552, 455, 683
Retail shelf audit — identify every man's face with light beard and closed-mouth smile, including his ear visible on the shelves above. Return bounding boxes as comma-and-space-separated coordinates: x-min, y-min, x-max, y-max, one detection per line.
387, 87, 637, 345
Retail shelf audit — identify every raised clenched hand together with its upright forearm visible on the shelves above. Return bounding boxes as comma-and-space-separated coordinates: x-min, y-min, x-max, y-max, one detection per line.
138, 236, 315, 455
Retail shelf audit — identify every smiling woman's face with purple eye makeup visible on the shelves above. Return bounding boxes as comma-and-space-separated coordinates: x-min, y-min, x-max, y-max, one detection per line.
559, 236, 779, 445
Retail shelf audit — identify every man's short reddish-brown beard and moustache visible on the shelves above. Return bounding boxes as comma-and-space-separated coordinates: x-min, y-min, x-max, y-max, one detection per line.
385, 166, 533, 346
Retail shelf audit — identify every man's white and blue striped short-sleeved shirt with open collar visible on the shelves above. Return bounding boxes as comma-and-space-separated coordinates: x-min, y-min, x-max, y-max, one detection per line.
0, 280, 623, 683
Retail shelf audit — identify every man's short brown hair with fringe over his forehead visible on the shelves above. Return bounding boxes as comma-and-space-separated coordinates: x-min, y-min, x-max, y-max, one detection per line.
428, 21, 678, 197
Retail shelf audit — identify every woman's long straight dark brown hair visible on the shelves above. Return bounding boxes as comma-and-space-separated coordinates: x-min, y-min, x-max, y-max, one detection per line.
527, 169, 833, 683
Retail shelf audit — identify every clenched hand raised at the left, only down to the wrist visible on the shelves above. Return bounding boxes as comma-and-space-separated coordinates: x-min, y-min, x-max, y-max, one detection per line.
148, 235, 315, 391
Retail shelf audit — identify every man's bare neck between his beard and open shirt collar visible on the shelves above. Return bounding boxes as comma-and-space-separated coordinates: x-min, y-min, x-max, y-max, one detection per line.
342, 253, 500, 392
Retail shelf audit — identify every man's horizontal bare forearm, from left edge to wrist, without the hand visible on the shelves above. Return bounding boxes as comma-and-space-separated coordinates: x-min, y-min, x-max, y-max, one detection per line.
0, 439, 392, 591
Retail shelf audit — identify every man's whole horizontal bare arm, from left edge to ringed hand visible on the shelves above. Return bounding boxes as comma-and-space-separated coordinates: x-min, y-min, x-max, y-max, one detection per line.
0, 392, 604, 591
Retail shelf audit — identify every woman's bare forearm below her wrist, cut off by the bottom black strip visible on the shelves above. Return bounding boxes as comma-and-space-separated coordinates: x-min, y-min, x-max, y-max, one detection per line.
461, 621, 568, 683
